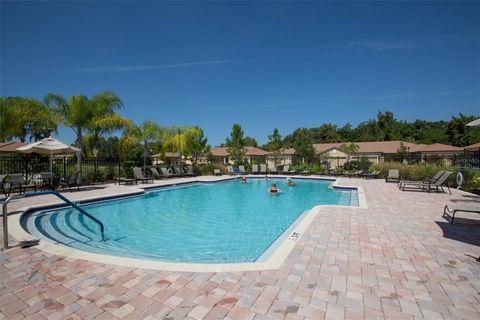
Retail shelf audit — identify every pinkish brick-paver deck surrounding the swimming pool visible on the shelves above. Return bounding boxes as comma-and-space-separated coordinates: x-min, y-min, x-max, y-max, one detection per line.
0, 177, 480, 320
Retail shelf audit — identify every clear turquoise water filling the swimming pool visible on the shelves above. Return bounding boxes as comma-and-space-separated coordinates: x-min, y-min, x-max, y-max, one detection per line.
22, 179, 358, 263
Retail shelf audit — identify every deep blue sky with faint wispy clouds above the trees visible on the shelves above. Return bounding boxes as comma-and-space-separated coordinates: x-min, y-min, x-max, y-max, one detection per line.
0, 1, 480, 145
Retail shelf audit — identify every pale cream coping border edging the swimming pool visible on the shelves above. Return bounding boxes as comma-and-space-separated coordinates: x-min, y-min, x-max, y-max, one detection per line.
8, 175, 368, 272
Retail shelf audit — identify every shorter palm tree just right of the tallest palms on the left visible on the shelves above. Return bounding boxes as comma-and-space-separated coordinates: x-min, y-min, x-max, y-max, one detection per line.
120, 120, 162, 169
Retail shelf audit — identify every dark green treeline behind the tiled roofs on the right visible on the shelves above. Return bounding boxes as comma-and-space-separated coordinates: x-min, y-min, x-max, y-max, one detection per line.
283, 111, 480, 147
